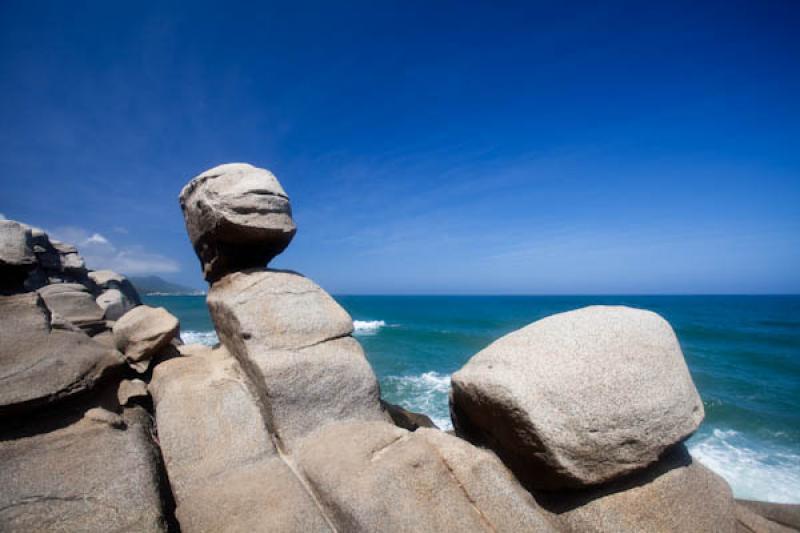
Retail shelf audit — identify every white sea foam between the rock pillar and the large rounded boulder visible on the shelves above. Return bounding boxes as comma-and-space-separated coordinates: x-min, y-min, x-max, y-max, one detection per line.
385, 372, 453, 429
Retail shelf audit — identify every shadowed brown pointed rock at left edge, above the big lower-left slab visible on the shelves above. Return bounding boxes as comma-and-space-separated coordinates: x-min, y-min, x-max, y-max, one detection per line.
0, 293, 123, 415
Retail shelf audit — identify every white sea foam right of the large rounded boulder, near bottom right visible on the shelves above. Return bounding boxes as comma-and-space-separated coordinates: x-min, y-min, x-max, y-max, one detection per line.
689, 429, 800, 503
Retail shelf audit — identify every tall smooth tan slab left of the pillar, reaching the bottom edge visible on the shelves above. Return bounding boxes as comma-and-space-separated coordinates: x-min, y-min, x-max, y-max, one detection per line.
150, 348, 330, 532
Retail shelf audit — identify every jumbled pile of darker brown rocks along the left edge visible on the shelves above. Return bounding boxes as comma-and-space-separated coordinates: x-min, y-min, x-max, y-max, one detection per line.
0, 221, 174, 532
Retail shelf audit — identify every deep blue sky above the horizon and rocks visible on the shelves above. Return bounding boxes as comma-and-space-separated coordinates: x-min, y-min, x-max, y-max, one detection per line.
0, 0, 800, 294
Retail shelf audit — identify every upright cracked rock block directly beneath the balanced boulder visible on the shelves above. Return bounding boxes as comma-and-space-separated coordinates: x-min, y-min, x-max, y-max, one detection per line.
208, 270, 387, 449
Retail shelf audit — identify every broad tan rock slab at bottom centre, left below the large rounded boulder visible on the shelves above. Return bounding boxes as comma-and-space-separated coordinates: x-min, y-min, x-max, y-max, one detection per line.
297, 422, 555, 532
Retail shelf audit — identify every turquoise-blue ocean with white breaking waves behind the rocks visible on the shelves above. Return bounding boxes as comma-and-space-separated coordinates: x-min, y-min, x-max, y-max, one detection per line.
144, 296, 800, 503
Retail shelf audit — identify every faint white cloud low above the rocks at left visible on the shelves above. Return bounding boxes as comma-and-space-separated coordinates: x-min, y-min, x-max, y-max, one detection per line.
50, 226, 180, 275
